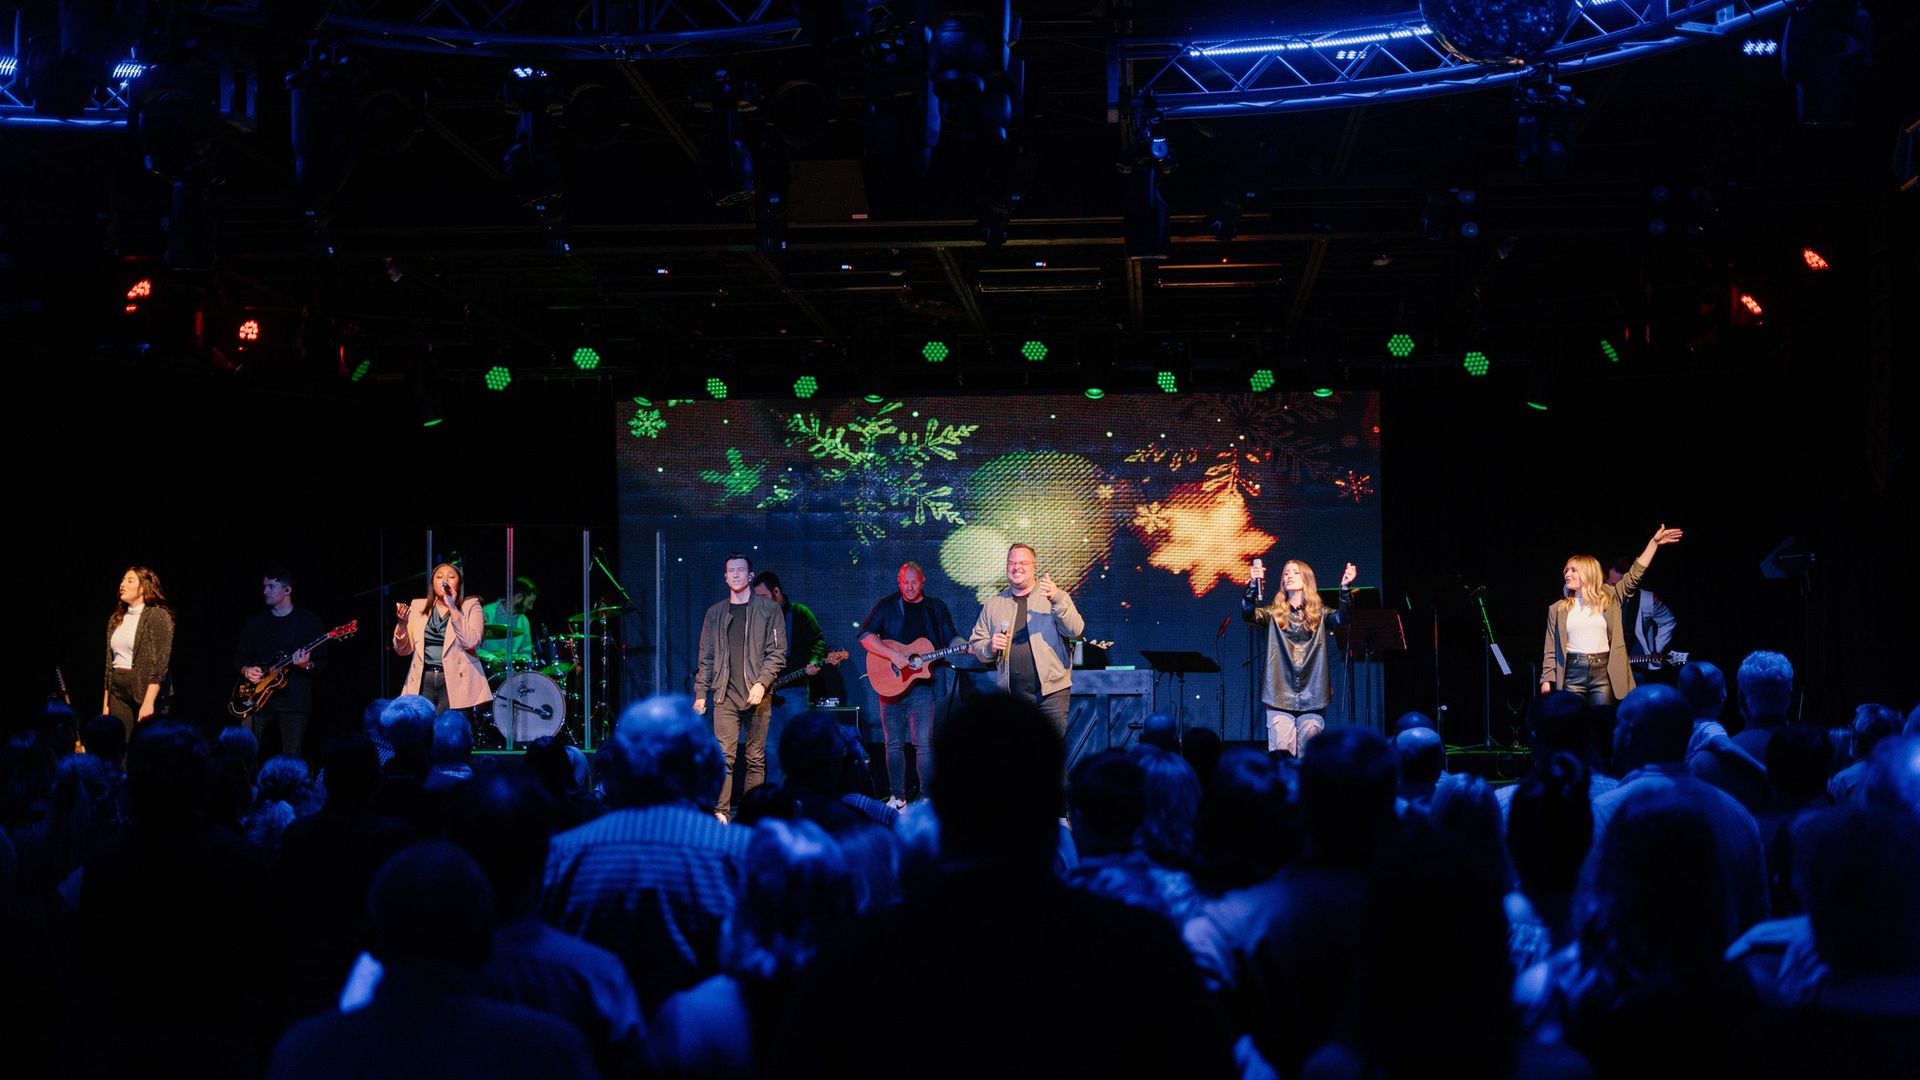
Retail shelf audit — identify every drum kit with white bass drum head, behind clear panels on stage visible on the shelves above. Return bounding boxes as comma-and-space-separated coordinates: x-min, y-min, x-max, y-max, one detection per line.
474, 607, 620, 748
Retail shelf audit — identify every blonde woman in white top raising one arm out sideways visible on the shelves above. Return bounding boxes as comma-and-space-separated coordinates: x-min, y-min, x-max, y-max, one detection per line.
1540, 525, 1682, 705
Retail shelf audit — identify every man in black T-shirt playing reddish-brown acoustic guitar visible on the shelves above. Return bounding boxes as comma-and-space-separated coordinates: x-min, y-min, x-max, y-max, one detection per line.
860, 563, 966, 809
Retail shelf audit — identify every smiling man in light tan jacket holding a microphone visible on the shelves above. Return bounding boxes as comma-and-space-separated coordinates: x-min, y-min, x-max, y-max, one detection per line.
968, 544, 1087, 740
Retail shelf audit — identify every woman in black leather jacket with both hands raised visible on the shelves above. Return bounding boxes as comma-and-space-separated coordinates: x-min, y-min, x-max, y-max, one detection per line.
1240, 559, 1359, 757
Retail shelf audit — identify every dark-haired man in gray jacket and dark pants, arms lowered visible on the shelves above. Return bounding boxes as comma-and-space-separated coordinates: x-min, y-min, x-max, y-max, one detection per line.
693, 553, 787, 821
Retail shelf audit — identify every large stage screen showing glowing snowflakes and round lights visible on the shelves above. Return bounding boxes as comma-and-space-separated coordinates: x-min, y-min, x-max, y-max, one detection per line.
616, 392, 1382, 740
